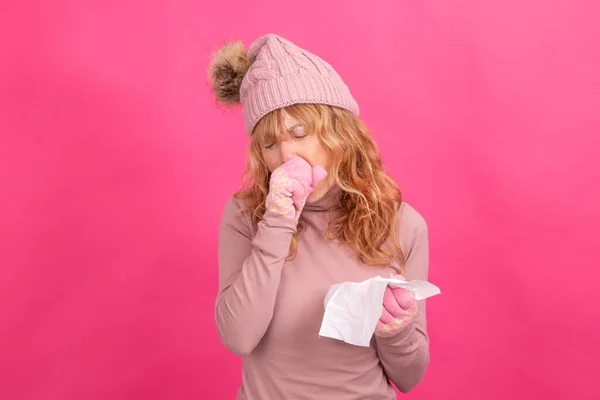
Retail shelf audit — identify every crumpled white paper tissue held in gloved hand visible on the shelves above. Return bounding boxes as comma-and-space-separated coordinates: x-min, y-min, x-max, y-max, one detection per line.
319, 276, 440, 347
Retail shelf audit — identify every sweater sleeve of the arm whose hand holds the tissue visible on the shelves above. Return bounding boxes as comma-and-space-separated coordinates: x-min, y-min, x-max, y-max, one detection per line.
376, 204, 429, 393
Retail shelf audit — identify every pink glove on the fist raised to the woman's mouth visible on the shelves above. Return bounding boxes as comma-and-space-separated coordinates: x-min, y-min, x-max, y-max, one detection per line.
265, 156, 327, 221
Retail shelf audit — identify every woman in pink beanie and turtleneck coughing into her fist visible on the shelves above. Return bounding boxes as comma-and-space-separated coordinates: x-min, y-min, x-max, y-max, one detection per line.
209, 34, 429, 400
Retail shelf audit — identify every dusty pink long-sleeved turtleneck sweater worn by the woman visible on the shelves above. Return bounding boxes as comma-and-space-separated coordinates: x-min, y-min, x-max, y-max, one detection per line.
215, 190, 429, 400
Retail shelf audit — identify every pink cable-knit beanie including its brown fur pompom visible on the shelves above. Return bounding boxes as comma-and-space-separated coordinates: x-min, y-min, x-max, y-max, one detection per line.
209, 34, 359, 135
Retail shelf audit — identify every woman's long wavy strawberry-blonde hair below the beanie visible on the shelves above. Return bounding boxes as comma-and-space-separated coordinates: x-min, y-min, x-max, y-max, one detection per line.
234, 104, 405, 267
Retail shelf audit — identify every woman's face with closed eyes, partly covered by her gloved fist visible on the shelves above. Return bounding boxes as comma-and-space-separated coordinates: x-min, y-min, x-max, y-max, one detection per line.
262, 111, 333, 203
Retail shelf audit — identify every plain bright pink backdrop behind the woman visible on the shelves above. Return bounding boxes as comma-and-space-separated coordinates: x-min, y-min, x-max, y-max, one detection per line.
0, 0, 600, 400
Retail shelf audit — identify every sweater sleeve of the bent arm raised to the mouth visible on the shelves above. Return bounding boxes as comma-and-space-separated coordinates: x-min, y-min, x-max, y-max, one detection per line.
215, 199, 297, 356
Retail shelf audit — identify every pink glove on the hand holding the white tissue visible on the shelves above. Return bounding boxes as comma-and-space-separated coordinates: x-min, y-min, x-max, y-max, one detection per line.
375, 275, 417, 337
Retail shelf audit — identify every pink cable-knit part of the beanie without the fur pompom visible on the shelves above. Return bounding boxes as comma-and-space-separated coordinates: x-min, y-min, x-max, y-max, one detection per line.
240, 34, 359, 135
